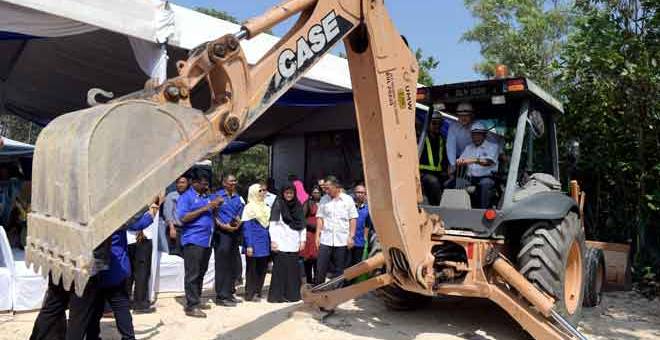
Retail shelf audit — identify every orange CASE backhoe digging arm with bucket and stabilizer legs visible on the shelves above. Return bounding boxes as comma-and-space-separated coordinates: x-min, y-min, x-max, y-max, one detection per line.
27, 0, 583, 339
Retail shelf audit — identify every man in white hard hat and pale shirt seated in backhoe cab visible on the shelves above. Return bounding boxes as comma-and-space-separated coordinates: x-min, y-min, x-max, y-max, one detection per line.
456, 122, 499, 209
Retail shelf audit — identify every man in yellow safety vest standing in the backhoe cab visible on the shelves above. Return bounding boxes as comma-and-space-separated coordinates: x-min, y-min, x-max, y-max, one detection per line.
419, 112, 446, 205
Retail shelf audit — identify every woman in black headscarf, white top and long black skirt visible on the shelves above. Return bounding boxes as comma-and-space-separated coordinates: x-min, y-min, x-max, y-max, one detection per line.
268, 184, 306, 302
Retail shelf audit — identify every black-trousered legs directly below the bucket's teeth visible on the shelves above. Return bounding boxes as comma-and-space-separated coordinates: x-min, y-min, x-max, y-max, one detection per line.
30, 277, 98, 340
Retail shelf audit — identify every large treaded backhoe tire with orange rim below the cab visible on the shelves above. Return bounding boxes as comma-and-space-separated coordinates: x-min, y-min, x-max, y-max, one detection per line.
518, 212, 586, 325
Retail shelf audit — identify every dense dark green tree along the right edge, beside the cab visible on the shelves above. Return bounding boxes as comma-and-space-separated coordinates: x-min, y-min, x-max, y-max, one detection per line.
557, 0, 660, 266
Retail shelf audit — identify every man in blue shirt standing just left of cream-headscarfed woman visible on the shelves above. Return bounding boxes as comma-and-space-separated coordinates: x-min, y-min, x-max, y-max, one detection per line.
213, 174, 245, 307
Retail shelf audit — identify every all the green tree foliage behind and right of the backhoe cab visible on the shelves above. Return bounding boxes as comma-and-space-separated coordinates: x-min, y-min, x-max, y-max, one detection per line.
464, 0, 660, 266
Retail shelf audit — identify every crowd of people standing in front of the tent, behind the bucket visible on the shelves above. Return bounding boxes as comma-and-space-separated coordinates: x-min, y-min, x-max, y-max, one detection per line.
31, 168, 373, 339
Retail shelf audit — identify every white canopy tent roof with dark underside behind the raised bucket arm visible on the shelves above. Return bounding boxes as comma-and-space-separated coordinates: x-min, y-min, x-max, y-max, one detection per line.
0, 0, 351, 124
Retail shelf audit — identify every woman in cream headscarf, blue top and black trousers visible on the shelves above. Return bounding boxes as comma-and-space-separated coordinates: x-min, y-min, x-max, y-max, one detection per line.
241, 184, 270, 301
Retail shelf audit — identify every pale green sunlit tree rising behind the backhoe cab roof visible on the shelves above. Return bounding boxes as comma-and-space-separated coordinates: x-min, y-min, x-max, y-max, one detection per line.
462, 0, 573, 92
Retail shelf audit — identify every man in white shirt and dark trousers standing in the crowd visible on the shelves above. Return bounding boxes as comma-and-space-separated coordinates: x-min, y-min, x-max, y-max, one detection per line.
316, 178, 358, 284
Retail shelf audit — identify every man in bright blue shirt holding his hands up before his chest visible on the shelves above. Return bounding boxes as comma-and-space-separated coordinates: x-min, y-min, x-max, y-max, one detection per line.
176, 169, 222, 318
